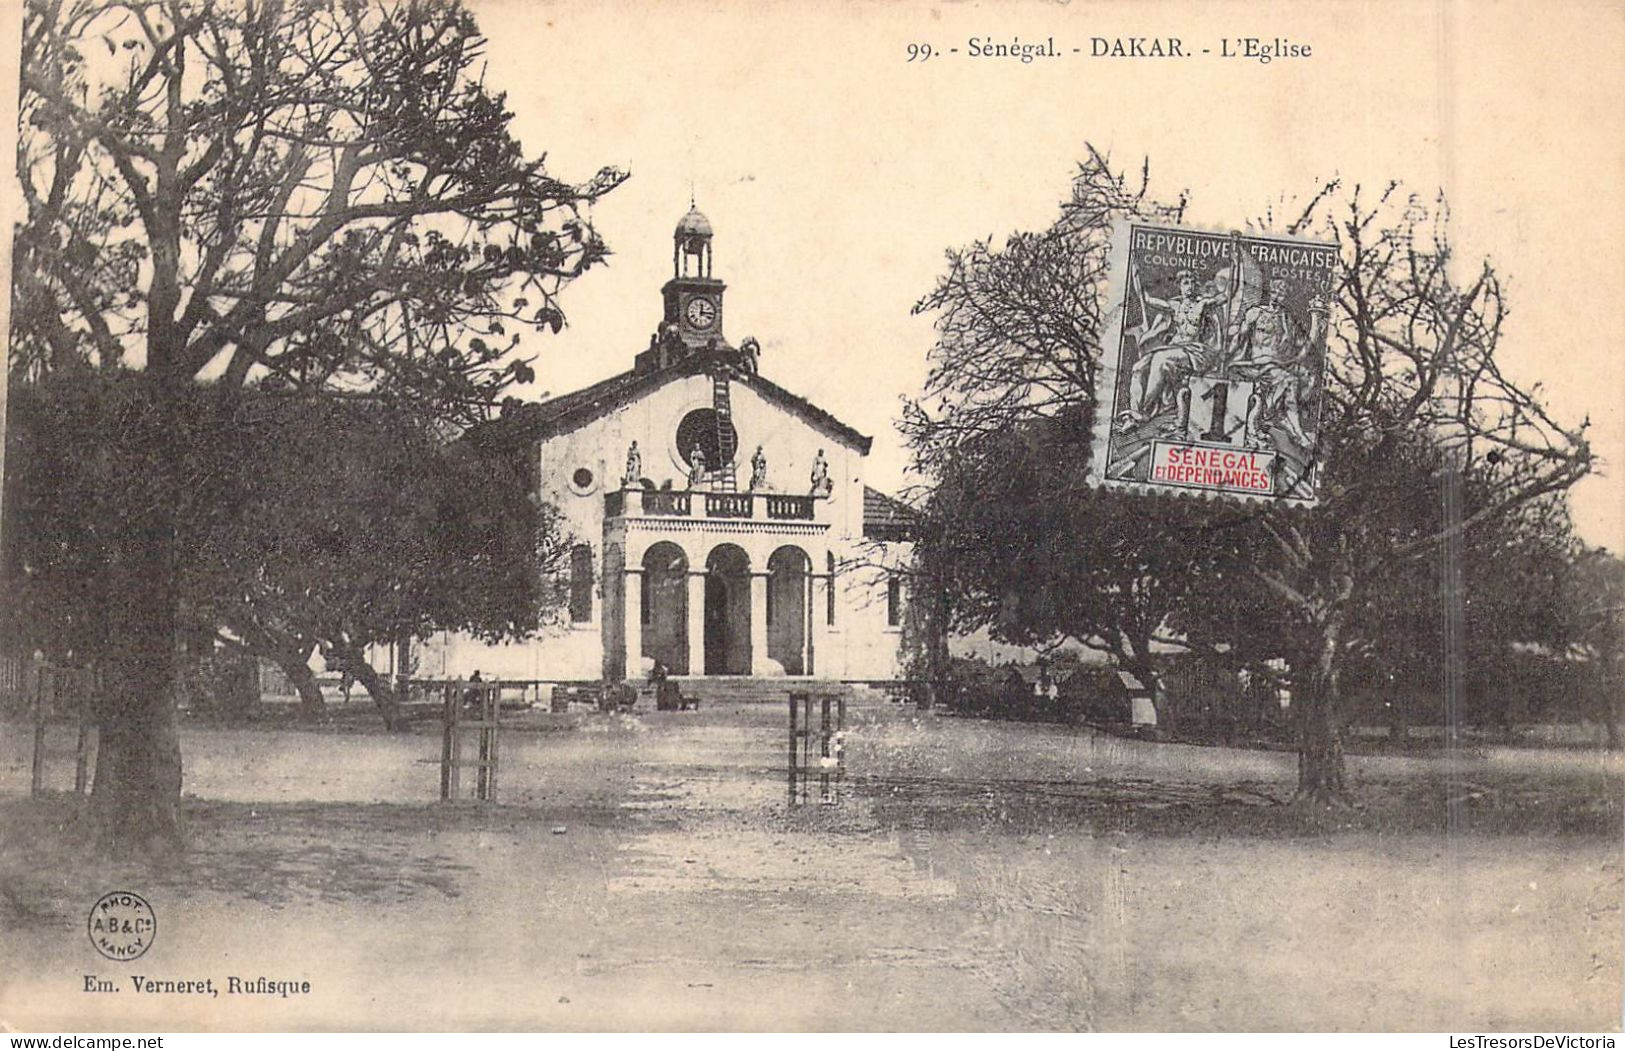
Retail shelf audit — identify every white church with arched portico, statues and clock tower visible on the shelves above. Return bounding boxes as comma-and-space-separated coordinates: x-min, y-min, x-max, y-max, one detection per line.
416, 210, 910, 682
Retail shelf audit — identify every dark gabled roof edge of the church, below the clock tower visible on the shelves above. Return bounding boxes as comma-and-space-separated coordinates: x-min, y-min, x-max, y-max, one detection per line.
486, 352, 874, 455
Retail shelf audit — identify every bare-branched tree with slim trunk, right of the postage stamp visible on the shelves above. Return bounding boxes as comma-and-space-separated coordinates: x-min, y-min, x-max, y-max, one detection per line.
1250, 185, 1593, 804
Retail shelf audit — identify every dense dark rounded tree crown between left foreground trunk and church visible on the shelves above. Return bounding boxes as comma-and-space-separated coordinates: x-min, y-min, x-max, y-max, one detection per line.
182, 395, 567, 726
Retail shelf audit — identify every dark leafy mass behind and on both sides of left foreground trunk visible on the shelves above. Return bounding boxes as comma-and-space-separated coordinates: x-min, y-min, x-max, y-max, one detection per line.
0, 372, 567, 723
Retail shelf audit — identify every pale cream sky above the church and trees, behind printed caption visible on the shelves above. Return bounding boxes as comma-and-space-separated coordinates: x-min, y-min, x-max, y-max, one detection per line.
475, 0, 1625, 547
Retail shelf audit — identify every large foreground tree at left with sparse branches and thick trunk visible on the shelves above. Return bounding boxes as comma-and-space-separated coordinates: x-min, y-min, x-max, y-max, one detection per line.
11, 0, 624, 843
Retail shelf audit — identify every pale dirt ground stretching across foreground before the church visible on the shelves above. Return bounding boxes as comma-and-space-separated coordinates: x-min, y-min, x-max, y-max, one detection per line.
0, 705, 1625, 1032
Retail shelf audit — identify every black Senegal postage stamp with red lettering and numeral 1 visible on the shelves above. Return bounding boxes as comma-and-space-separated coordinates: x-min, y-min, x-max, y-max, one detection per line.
1089, 223, 1337, 505
